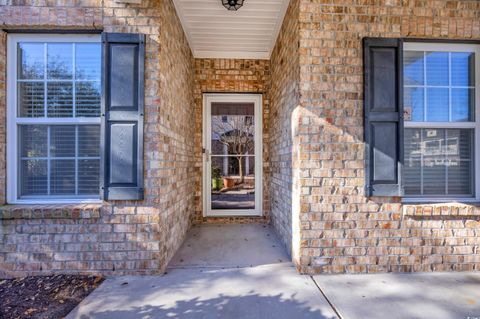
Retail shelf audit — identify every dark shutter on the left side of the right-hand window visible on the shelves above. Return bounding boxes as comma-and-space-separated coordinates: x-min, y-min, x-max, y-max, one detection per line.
363, 38, 403, 196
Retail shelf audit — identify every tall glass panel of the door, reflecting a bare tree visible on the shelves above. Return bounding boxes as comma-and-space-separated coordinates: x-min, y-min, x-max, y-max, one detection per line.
209, 103, 255, 210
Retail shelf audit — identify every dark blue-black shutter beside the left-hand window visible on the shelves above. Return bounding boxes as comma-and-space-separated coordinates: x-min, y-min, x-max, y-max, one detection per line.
100, 33, 145, 200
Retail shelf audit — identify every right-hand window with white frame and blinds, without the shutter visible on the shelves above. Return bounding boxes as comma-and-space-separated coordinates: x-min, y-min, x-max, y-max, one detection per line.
403, 43, 480, 199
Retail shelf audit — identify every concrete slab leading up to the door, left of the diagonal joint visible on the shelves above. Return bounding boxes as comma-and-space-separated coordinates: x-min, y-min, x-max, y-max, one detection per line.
67, 225, 337, 319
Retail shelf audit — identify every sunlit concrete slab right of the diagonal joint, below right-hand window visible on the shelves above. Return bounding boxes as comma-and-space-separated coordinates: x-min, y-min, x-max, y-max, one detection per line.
314, 272, 480, 319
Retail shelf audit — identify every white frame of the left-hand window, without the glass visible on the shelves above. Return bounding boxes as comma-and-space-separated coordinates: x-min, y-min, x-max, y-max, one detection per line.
6, 34, 101, 204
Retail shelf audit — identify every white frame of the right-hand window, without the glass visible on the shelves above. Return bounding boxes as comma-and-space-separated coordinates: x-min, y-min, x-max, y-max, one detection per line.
402, 42, 480, 203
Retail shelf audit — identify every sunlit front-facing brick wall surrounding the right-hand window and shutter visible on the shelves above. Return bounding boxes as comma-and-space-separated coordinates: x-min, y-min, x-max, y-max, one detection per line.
298, 0, 480, 273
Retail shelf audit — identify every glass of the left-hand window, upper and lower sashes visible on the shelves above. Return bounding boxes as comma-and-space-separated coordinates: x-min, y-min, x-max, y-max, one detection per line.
17, 43, 101, 197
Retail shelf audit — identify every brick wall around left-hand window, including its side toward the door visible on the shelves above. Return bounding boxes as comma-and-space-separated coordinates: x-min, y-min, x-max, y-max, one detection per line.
0, 0, 195, 275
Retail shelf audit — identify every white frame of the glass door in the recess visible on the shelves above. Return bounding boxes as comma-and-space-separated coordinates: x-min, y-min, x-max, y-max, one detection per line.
202, 93, 263, 217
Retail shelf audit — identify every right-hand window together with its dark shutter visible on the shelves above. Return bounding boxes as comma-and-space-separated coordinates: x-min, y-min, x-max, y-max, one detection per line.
364, 38, 480, 200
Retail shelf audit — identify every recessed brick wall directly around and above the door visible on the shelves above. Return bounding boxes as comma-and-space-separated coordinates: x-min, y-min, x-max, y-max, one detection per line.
195, 59, 270, 223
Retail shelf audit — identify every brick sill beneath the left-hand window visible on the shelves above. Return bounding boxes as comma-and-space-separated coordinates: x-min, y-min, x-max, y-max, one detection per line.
0, 203, 103, 220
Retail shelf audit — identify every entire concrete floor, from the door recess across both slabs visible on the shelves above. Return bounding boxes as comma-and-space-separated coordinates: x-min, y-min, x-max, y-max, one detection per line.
67, 225, 480, 319
